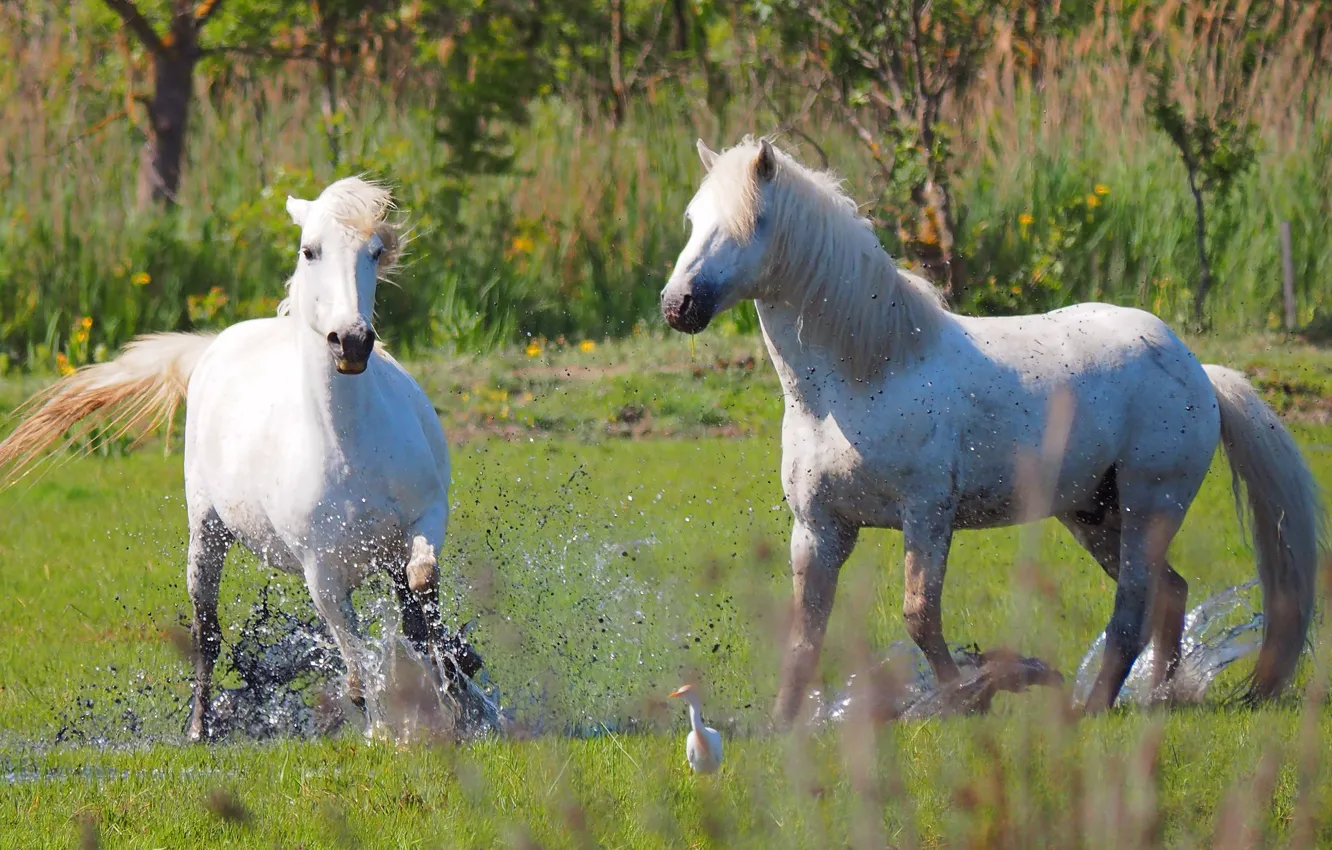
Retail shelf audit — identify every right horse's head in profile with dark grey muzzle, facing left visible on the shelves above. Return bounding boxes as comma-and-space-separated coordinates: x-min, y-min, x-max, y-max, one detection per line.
662, 139, 779, 333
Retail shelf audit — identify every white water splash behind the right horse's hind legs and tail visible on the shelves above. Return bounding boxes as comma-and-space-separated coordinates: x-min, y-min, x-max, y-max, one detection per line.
1074, 581, 1263, 706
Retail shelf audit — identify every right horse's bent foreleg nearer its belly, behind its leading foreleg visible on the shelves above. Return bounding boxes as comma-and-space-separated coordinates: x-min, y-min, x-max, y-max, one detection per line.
902, 506, 958, 685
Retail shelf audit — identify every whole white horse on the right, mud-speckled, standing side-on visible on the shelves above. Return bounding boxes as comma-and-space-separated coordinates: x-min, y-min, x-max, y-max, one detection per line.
661, 139, 1324, 725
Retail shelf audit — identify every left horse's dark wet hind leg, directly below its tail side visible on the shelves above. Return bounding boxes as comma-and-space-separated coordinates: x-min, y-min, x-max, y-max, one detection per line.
185, 509, 234, 741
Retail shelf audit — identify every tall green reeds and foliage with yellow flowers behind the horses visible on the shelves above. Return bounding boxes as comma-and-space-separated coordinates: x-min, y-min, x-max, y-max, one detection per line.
0, 0, 1332, 370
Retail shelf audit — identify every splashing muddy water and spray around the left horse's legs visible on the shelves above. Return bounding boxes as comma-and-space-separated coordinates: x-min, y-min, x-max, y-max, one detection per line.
23, 534, 669, 756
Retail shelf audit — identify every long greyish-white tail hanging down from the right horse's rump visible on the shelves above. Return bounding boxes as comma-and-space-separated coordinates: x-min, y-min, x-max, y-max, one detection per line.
1203, 365, 1325, 702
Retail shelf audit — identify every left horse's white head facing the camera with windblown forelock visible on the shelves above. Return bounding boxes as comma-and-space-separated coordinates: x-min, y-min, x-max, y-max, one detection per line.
286, 177, 398, 374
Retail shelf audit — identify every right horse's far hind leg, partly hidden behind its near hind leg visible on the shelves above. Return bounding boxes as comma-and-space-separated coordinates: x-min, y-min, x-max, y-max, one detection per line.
1059, 508, 1188, 690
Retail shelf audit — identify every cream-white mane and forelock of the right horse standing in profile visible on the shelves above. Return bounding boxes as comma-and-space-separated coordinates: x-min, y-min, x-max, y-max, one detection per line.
706, 137, 948, 380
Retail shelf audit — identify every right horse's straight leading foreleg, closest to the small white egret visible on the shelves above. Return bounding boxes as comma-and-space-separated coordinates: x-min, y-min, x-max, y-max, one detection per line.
773, 521, 859, 727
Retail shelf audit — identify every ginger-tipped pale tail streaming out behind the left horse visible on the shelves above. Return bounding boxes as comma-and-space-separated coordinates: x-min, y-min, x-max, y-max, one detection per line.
0, 333, 217, 486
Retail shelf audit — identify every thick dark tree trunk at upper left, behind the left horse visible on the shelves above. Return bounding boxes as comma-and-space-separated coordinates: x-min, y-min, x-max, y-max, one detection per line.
139, 41, 198, 208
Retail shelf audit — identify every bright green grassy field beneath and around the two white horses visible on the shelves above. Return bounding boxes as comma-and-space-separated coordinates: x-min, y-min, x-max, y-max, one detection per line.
0, 334, 1332, 847
